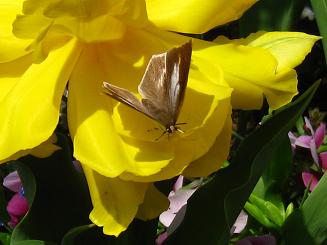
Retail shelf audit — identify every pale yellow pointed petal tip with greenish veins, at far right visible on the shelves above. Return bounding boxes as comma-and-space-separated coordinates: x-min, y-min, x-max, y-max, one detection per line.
236, 31, 321, 73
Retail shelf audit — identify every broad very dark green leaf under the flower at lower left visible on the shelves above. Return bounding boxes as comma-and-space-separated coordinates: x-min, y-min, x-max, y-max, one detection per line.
11, 135, 92, 245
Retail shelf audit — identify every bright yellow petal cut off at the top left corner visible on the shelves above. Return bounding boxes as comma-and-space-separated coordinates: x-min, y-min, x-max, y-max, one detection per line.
0, 0, 32, 63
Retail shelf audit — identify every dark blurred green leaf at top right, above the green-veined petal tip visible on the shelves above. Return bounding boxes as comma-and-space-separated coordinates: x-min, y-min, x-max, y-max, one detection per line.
239, 0, 306, 36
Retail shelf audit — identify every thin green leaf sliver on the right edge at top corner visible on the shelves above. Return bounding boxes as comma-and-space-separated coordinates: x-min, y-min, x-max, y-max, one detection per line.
311, 0, 327, 64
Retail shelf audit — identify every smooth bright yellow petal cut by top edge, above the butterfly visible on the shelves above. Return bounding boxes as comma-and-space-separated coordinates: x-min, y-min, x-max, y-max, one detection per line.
146, 0, 257, 34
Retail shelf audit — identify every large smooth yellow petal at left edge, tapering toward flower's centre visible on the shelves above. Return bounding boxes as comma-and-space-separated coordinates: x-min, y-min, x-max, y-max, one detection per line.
0, 40, 78, 159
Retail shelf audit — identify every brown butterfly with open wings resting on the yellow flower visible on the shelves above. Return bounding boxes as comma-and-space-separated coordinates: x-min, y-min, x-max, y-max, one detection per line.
103, 40, 192, 139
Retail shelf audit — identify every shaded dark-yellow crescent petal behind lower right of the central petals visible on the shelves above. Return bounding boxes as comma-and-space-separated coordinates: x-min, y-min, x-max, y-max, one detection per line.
183, 112, 232, 177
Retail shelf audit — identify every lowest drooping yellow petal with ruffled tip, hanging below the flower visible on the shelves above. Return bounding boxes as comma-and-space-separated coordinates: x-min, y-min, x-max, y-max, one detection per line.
83, 166, 148, 236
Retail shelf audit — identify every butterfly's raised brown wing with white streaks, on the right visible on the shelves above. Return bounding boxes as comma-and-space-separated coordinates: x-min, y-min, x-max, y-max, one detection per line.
138, 41, 192, 128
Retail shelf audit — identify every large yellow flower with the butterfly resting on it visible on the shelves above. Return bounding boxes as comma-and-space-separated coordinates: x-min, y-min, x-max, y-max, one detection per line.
0, 0, 317, 236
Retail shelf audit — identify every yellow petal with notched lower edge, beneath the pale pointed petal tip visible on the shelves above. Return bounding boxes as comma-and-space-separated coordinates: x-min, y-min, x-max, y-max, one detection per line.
214, 38, 297, 109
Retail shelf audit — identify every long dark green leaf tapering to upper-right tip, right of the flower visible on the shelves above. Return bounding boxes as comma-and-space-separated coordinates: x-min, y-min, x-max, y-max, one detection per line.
166, 82, 319, 245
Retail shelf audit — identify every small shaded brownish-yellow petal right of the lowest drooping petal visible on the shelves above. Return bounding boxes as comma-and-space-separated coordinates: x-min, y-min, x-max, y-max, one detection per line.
136, 185, 169, 220
